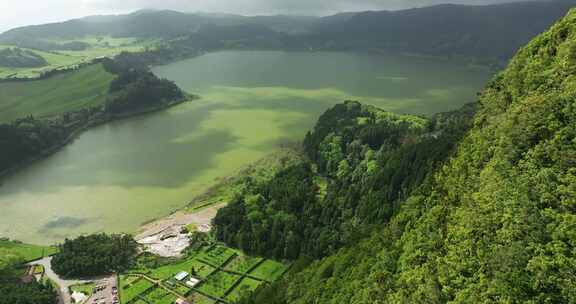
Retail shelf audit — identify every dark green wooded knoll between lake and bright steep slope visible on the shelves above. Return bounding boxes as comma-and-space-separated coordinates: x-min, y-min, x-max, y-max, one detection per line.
214, 102, 474, 259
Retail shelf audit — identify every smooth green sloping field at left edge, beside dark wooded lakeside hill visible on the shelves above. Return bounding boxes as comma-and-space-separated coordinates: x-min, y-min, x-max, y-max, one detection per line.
0, 64, 114, 122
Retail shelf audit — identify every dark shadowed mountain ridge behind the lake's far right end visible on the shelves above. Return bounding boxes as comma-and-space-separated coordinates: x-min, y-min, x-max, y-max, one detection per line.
308, 0, 576, 59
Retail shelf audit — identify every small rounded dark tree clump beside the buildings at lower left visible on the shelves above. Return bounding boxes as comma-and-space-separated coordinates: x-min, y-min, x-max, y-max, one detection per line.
52, 234, 138, 278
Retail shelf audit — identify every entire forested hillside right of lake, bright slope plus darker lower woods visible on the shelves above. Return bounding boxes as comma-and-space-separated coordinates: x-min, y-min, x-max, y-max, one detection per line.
215, 11, 576, 304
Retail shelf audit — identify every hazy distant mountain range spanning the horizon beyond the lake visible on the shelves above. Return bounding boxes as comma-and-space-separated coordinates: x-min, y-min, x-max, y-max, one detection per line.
0, 0, 576, 62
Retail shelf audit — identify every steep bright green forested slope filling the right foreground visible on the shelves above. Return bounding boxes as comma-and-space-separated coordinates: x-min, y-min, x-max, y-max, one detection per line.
217, 7, 576, 304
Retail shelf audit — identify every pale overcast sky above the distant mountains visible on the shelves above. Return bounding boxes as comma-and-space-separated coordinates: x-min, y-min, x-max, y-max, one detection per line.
0, 0, 511, 32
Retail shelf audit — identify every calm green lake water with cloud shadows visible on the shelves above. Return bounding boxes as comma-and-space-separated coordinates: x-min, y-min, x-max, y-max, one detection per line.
0, 52, 490, 244
